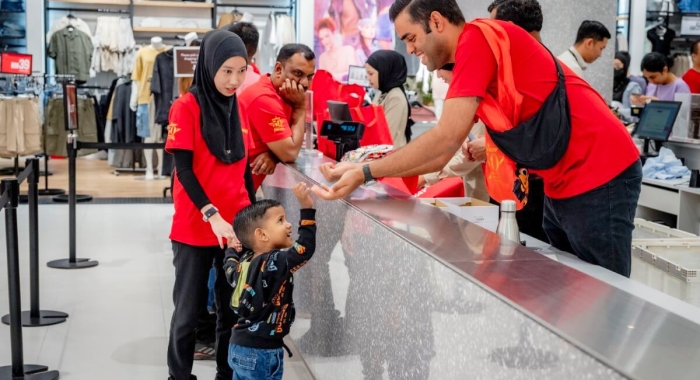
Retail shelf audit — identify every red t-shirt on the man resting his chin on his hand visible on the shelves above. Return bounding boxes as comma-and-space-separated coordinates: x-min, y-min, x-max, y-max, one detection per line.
238, 74, 293, 190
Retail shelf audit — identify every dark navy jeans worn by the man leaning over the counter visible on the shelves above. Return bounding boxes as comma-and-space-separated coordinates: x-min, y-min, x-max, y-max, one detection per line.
543, 161, 642, 277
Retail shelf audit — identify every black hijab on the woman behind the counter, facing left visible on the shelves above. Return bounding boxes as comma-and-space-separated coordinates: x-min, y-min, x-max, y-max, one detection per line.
367, 50, 413, 141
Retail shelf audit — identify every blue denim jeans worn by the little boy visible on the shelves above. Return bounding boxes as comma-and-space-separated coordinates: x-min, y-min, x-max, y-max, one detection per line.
228, 344, 284, 380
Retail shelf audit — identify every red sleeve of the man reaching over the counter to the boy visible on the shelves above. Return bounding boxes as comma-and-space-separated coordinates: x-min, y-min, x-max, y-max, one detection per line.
446, 25, 497, 99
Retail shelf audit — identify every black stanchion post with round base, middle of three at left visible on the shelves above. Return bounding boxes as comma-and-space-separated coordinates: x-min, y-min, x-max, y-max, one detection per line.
2, 158, 68, 327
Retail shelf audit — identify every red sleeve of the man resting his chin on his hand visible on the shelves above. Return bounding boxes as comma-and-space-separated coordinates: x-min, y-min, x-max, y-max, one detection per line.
248, 95, 292, 144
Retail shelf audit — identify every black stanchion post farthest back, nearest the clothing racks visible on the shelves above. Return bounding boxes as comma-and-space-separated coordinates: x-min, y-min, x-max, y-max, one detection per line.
47, 135, 98, 269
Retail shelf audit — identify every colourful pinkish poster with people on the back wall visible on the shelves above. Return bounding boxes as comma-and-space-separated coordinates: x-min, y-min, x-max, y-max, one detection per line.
314, 0, 394, 83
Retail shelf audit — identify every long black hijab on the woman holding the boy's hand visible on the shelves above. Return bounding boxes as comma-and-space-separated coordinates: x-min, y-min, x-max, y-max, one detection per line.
190, 30, 248, 164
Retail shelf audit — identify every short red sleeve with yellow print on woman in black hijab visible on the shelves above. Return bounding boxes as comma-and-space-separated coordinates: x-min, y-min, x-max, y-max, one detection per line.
165, 94, 199, 153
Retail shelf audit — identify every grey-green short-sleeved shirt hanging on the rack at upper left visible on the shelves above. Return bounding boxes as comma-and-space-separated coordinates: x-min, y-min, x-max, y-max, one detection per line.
47, 26, 93, 82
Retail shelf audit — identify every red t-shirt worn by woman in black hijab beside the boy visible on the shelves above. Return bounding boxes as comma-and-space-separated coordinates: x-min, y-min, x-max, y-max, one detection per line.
165, 93, 250, 247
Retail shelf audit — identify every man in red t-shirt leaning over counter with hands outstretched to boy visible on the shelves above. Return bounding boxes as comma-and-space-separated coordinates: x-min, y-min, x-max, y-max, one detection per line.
313, 0, 642, 277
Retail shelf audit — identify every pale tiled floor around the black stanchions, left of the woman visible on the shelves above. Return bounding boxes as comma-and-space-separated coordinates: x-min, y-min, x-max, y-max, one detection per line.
0, 204, 311, 380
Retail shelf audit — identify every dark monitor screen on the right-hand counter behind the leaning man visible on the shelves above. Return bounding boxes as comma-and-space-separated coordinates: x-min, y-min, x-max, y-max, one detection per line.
634, 101, 681, 141
